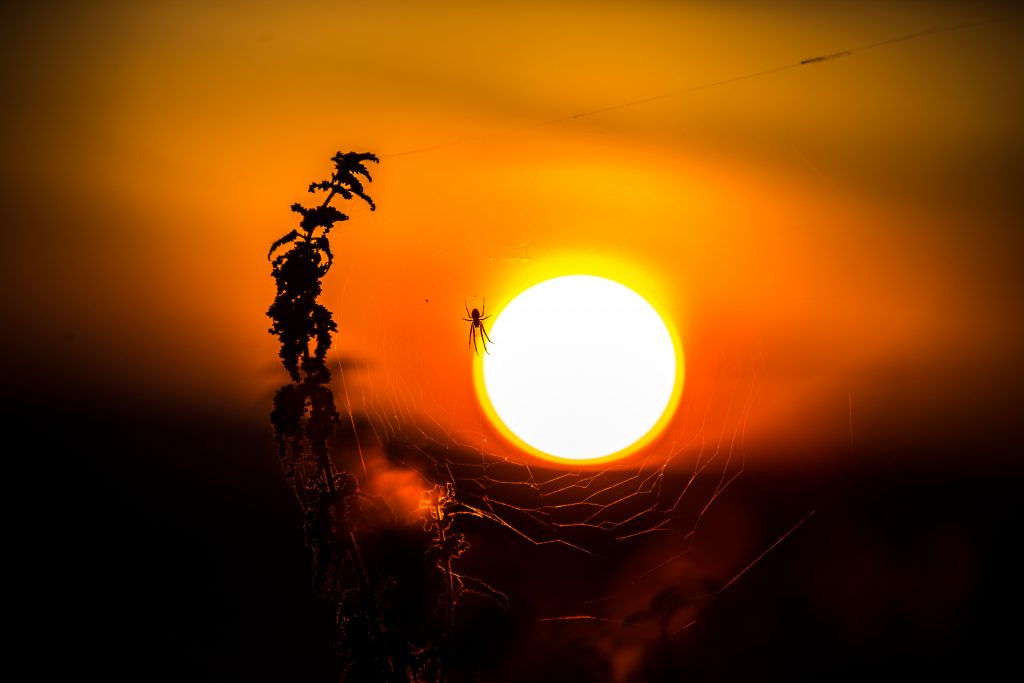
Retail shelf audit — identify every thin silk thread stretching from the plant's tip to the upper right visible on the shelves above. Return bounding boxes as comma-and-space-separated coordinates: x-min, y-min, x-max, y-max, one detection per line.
380, 17, 999, 159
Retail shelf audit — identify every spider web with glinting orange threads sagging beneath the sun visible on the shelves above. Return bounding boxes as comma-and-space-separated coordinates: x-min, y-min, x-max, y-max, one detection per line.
323, 296, 764, 602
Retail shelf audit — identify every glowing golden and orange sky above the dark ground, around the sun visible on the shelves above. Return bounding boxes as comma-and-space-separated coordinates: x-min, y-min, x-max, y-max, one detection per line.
0, 2, 1024, 464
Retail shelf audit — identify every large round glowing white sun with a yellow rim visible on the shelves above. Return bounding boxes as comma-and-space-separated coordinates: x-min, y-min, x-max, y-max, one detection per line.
476, 274, 683, 463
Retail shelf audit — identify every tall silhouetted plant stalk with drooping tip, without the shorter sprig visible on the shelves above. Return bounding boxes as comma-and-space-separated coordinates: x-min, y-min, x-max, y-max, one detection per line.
267, 152, 407, 680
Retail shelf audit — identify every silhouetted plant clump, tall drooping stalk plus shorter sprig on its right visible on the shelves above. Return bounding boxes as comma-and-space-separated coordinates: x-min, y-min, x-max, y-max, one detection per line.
267, 152, 507, 683
